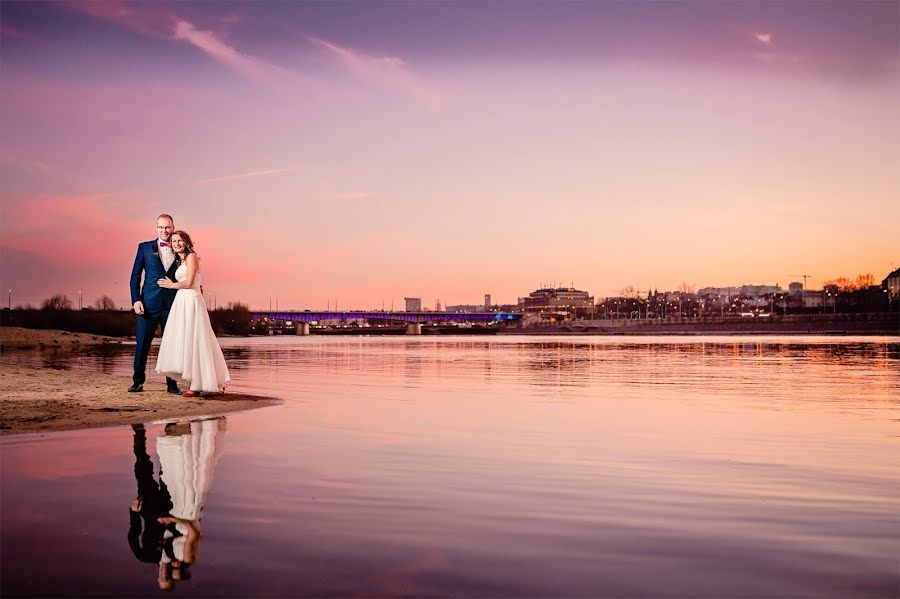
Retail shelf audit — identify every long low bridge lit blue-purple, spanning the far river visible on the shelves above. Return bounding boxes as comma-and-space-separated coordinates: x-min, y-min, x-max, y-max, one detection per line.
250, 310, 522, 335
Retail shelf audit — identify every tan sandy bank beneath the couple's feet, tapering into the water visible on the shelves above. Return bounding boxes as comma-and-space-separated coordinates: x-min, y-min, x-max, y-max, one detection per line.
0, 364, 281, 435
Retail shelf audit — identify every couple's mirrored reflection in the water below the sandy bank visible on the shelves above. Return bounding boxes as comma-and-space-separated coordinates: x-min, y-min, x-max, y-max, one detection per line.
128, 417, 225, 590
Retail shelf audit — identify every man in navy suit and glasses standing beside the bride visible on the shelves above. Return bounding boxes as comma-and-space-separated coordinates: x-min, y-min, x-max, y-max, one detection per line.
128, 214, 181, 395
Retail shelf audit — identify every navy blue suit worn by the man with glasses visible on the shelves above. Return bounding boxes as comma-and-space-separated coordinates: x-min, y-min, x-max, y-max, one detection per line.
131, 239, 179, 387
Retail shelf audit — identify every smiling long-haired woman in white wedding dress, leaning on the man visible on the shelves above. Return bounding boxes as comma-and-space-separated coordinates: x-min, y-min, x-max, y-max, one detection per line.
156, 231, 231, 397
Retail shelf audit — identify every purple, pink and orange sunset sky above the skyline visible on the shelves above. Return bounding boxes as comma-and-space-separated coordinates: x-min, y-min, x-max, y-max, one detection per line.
0, 0, 900, 309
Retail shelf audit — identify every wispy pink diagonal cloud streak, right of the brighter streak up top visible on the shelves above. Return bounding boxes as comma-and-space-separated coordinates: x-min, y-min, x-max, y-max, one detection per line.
307, 36, 446, 110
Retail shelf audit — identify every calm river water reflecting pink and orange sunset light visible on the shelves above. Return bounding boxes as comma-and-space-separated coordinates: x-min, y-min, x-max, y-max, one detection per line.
0, 337, 900, 597
